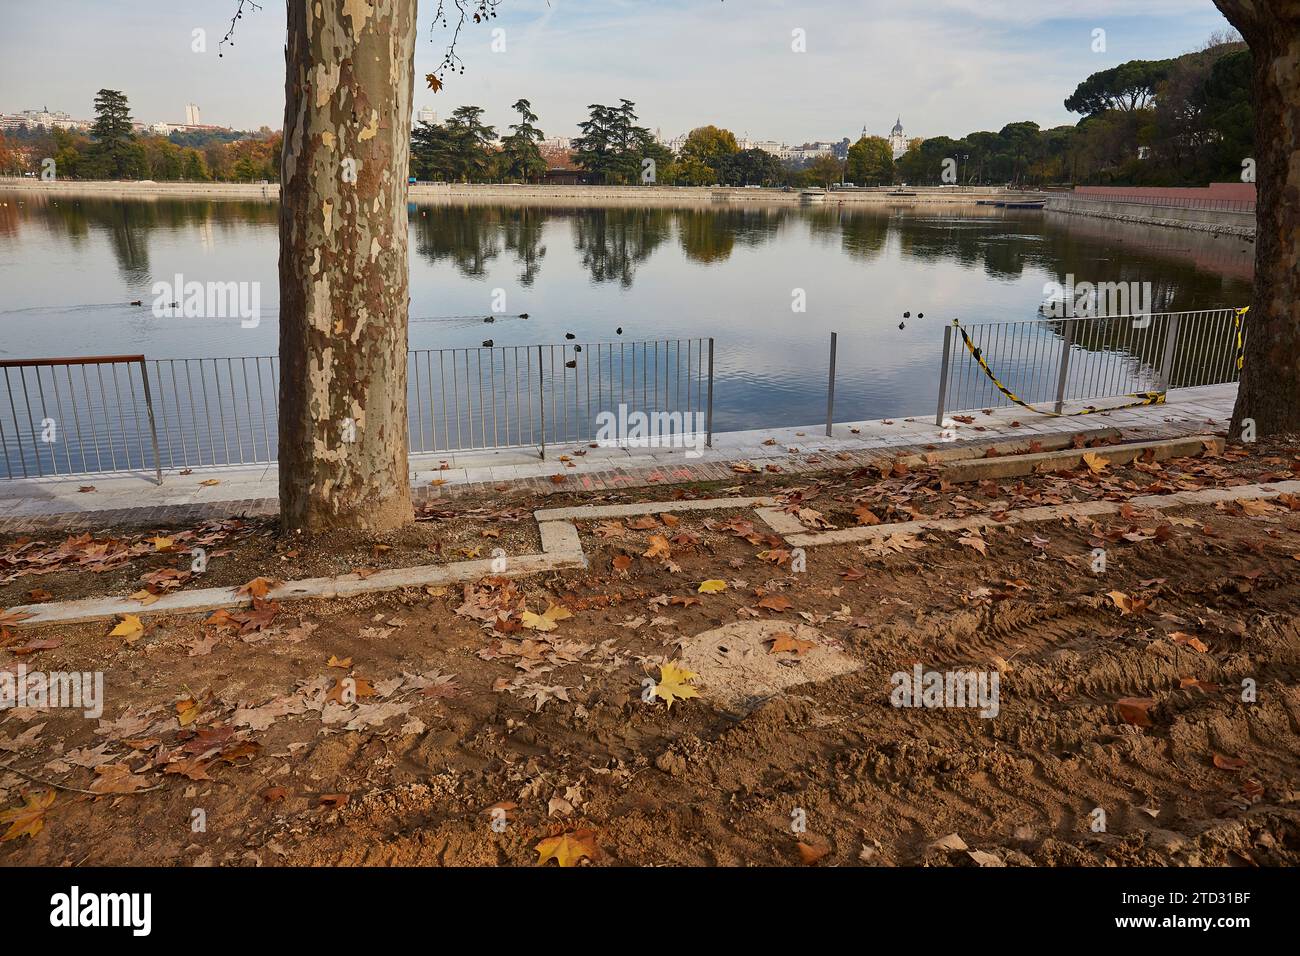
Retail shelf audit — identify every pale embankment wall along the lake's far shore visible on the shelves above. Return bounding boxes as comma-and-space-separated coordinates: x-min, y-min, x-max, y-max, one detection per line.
0, 177, 1041, 206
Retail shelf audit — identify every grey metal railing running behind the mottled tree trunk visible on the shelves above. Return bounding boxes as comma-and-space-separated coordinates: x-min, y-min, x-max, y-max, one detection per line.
0, 338, 714, 481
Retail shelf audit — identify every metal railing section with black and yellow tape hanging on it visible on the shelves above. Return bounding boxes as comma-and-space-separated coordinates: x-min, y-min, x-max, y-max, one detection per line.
935, 308, 1245, 425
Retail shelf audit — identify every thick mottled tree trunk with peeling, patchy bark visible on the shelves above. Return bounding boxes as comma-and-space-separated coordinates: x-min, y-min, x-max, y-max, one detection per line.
280, 0, 416, 532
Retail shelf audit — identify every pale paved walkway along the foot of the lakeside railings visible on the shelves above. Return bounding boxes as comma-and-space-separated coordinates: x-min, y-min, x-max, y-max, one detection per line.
0, 385, 1236, 533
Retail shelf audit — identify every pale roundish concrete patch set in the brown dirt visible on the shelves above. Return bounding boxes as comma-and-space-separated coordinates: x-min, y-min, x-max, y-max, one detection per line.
681, 620, 862, 711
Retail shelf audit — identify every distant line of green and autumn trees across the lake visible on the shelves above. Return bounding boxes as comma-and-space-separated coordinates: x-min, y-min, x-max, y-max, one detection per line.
0, 35, 1255, 187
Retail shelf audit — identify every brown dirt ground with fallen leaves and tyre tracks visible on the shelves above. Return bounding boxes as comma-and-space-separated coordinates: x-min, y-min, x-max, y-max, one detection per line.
0, 444, 1300, 866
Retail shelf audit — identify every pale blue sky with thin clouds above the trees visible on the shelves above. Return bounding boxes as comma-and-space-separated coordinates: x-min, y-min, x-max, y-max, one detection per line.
0, 0, 1229, 144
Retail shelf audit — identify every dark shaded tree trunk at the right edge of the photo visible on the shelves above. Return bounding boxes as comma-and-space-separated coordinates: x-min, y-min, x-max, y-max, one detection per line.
1216, 0, 1300, 438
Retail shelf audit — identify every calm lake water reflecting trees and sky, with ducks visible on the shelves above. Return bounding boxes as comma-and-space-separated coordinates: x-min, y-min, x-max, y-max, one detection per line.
0, 191, 1253, 431
